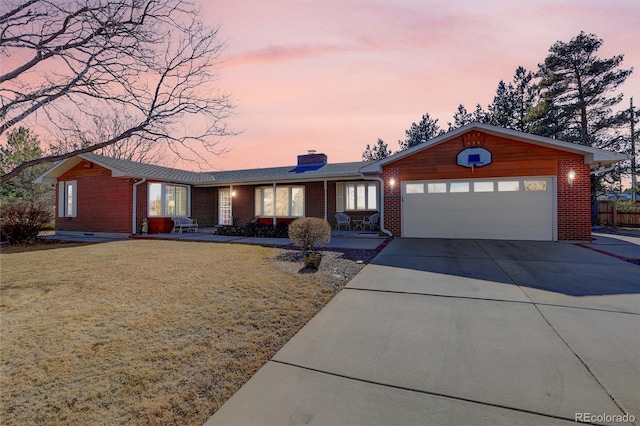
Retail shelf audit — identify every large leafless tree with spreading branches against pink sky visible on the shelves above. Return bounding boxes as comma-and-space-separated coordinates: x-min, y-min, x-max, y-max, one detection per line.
0, 0, 232, 182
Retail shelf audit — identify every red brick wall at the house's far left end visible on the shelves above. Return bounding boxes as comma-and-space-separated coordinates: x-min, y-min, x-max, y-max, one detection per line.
56, 173, 132, 234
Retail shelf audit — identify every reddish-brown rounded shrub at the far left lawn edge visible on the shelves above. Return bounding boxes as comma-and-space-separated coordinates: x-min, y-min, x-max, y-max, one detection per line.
0, 201, 53, 243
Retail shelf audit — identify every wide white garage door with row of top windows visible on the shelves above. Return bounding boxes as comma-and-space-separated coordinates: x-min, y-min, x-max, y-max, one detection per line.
402, 177, 554, 241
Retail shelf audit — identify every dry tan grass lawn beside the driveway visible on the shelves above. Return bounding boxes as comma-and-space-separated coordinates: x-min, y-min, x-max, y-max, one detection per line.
0, 240, 333, 425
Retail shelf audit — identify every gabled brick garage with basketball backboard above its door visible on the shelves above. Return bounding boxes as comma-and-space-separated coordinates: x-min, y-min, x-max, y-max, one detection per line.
360, 123, 627, 241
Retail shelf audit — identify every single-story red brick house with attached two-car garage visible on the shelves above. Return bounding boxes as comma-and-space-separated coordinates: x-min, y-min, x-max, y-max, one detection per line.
36, 123, 627, 241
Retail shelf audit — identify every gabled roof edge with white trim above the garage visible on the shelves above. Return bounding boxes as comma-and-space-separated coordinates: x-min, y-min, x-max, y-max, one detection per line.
360, 123, 628, 173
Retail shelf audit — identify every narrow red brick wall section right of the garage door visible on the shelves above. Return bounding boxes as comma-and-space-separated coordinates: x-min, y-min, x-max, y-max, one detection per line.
558, 159, 591, 241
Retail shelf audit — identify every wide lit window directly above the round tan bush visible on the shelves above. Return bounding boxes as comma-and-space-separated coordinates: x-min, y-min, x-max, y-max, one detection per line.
255, 186, 304, 217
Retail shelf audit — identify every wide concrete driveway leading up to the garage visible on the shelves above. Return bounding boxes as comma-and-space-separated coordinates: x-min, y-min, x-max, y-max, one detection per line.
207, 239, 640, 425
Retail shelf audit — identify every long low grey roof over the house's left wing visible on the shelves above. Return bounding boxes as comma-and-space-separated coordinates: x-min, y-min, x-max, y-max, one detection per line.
34, 153, 367, 186
